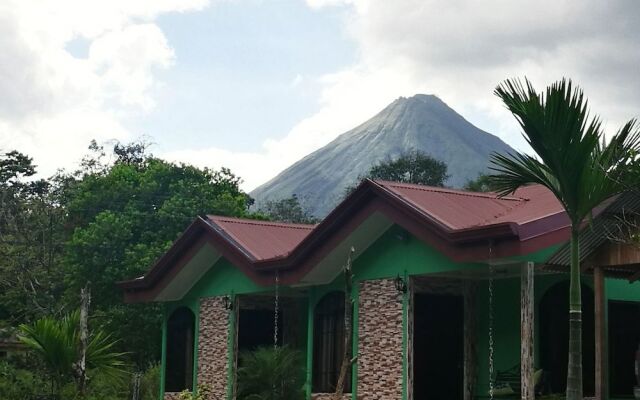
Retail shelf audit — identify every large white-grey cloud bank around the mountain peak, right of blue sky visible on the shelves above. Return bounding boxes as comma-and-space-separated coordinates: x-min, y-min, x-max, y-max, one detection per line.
169, 0, 640, 189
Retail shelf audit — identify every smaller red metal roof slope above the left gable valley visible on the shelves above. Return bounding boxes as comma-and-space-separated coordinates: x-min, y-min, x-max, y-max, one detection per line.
207, 215, 315, 260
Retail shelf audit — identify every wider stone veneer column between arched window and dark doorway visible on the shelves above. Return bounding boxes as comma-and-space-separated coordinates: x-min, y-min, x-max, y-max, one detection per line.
358, 279, 403, 400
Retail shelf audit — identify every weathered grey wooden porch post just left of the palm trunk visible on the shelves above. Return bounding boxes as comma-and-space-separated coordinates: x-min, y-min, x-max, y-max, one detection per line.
520, 262, 535, 400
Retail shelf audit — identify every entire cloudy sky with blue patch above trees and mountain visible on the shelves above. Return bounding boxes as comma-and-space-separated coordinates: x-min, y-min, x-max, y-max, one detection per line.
0, 0, 640, 190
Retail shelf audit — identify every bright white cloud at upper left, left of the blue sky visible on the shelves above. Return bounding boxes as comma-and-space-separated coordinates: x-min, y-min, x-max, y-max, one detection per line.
0, 0, 207, 174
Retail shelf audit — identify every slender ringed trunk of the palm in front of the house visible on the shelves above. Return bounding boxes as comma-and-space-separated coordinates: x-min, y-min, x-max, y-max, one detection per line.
567, 230, 582, 400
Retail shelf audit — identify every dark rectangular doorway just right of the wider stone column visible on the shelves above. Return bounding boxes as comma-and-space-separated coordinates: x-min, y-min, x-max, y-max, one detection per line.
413, 293, 464, 400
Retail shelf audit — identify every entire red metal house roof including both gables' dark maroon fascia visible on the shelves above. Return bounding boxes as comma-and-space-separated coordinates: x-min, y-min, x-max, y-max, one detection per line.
120, 180, 580, 301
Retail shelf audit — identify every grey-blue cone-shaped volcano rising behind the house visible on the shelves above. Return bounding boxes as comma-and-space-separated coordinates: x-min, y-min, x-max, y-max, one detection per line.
251, 94, 512, 217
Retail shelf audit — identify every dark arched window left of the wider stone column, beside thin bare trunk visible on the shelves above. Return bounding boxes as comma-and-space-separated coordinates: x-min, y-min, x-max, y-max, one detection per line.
313, 292, 351, 393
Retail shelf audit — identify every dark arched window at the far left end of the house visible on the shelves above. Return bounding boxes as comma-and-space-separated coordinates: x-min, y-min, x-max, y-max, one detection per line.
164, 307, 195, 392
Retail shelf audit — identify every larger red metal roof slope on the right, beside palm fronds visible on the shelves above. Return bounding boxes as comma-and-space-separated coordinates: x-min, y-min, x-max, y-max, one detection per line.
375, 181, 564, 230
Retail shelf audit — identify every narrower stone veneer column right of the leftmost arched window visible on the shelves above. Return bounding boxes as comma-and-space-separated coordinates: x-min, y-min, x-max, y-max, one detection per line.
197, 296, 229, 399
